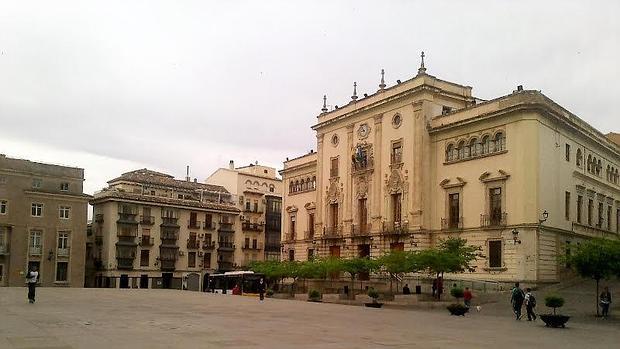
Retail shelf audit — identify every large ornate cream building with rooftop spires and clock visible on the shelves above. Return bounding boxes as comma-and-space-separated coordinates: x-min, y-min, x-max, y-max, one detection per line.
282, 57, 620, 282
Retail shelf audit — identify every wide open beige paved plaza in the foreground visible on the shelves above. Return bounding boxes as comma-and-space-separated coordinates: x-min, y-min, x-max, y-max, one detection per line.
0, 288, 620, 349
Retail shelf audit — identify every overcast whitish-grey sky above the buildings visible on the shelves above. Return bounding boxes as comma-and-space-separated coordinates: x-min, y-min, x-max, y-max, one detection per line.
0, 0, 620, 194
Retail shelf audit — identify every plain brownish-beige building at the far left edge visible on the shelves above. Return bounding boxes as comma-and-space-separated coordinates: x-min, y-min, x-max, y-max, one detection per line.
0, 154, 90, 287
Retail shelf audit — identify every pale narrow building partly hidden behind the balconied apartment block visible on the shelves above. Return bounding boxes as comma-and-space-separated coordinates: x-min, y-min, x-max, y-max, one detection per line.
206, 160, 282, 260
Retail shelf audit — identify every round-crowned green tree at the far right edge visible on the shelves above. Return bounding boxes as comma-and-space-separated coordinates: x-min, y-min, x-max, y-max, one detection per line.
564, 238, 620, 316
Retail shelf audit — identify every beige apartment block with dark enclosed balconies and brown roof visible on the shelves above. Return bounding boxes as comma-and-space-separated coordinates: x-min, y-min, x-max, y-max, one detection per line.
91, 169, 242, 290
